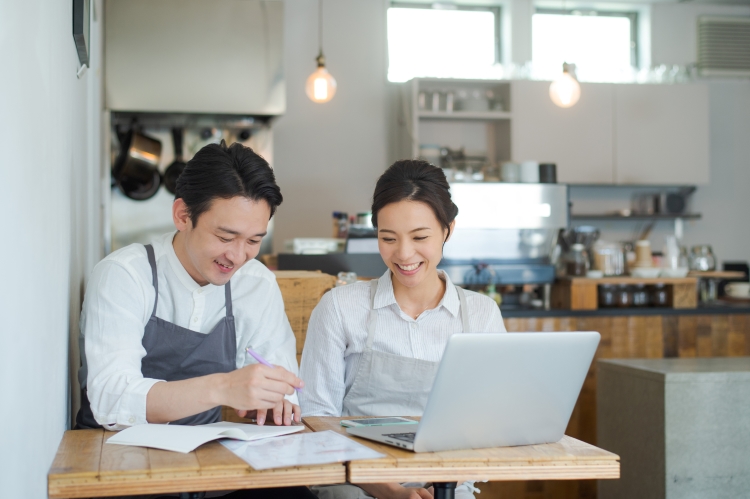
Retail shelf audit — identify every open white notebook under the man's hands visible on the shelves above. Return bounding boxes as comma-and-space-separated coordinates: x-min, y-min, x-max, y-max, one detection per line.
107, 421, 305, 453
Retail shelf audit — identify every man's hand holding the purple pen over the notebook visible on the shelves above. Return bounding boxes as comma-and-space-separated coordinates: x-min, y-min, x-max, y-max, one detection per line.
219, 364, 304, 414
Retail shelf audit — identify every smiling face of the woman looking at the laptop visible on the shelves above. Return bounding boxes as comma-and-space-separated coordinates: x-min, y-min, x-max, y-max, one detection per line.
378, 201, 455, 288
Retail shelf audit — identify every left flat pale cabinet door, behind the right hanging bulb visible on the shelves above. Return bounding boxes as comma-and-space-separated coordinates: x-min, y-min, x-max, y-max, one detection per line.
511, 81, 615, 184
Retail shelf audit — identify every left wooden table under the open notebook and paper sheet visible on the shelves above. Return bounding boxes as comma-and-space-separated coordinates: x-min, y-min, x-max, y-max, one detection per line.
47, 430, 346, 499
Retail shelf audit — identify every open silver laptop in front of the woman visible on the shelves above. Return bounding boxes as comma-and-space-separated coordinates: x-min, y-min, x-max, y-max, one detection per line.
346, 332, 600, 452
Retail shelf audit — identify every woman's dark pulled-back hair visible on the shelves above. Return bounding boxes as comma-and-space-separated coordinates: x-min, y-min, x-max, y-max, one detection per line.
372, 159, 458, 235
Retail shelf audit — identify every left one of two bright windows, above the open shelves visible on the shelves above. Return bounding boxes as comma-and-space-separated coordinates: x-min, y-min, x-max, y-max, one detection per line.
388, 2, 502, 81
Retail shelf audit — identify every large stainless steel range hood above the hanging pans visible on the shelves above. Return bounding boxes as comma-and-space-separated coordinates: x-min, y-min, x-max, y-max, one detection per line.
104, 0, 286, 116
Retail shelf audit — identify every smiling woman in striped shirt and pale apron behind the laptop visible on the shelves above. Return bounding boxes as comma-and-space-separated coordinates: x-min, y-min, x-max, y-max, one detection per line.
300, 160, 505, 499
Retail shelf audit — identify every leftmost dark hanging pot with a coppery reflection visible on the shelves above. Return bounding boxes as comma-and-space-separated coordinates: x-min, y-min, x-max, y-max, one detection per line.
112, 128, 161, 201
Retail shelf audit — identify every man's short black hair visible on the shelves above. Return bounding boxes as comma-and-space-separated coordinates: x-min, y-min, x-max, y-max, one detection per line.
175, 140, 284, 226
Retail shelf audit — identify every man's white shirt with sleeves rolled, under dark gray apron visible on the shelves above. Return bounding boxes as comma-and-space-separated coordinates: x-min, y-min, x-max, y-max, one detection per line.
79, 232, 298, 430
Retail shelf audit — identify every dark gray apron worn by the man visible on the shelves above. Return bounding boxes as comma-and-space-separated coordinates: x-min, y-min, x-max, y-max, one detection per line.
76, 244, 237, 429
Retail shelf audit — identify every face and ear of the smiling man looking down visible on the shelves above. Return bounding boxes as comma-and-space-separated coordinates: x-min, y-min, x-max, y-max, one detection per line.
172, 196, 271, 286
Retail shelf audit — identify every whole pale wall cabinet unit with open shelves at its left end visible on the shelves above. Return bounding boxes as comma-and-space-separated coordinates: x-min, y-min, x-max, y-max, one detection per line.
396, 79, 709, 185
